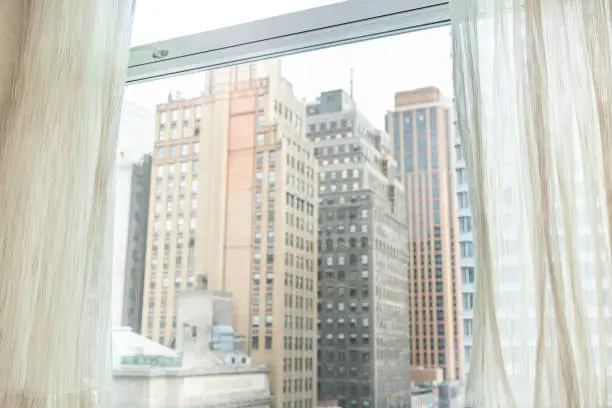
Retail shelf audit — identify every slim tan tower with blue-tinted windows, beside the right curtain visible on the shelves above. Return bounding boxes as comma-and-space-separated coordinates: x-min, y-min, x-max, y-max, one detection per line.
387, 87, 463, 380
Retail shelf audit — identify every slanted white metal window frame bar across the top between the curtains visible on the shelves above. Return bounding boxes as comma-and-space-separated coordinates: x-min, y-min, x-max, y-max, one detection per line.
126, 0, 450, 85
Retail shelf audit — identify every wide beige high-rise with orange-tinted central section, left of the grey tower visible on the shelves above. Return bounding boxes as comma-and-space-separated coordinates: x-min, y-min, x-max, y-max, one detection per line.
143, 61, 317, 408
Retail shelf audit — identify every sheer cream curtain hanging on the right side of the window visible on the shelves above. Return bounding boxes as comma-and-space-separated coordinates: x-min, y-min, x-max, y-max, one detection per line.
451, 0, 612, 408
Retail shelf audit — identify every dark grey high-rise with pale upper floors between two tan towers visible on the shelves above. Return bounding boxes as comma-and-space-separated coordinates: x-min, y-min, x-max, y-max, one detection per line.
307, 90, 410, 408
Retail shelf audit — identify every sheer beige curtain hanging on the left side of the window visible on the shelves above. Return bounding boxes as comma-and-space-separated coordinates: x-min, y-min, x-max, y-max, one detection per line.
0, 0, 133, 408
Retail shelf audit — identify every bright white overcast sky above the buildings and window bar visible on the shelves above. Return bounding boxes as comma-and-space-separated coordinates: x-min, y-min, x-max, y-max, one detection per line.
125, 0, 452, 139
